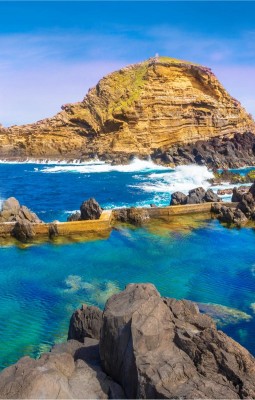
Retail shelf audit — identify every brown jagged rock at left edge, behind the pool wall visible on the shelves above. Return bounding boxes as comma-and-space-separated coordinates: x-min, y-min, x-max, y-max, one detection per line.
0, 197, 42, 223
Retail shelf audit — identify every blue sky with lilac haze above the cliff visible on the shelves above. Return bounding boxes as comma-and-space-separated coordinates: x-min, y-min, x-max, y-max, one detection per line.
0, 1, 255, 126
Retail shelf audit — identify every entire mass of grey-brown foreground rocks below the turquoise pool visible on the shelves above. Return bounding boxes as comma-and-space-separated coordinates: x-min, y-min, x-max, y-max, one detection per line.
0, 284, 255, 399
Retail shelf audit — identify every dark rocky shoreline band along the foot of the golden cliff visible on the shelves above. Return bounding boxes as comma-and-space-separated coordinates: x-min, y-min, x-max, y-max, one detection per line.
1, 131, 255, 169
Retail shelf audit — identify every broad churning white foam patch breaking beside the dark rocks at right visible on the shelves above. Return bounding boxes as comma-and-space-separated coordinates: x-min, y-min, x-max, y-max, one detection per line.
131, 165, 213, 193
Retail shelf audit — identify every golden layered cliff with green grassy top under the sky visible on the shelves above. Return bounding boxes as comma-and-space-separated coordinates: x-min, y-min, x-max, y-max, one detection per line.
0, 57, 255, 164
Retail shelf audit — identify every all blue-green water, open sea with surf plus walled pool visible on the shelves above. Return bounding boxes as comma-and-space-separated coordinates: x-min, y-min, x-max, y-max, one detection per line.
0, 160, 255, 368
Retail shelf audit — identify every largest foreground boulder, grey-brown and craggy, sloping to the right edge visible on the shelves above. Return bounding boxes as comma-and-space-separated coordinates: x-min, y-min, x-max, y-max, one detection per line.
100, 284, 255, 399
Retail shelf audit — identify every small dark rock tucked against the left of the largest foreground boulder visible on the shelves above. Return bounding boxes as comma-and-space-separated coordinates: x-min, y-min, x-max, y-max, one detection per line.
68, 304, 103, 342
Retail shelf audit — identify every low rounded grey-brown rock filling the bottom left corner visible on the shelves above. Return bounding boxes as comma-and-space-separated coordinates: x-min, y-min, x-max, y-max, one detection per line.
0, 338, 124, 399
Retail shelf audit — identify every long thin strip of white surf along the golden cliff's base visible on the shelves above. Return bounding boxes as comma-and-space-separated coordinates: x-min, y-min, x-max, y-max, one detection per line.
40, 158, 170, 174
